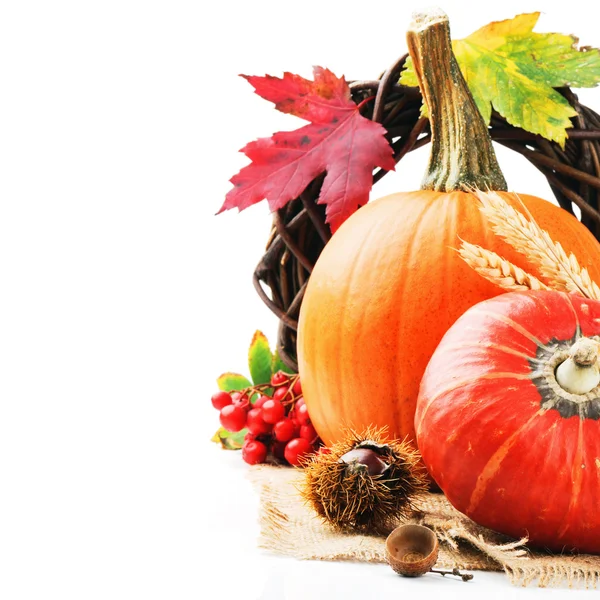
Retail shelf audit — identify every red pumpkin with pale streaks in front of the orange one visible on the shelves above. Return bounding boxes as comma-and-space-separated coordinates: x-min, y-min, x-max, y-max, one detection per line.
415, 291, 600, 553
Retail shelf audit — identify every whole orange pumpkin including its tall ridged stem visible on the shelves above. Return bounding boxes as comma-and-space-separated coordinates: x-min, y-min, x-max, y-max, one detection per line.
298, 12, 600, 444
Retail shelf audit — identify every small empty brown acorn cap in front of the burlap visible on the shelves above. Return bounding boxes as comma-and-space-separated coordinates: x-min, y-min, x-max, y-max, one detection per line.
385, 524, 438, 577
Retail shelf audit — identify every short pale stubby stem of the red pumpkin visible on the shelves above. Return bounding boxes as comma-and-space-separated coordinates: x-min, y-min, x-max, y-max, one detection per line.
556, 338, 600, 394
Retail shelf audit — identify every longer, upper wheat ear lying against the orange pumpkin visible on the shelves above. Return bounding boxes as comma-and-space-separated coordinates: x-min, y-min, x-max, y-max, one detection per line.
475, 190, 600, 300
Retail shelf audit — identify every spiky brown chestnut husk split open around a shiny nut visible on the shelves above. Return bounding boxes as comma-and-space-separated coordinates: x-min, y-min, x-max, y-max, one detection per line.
300, 428, 428, 535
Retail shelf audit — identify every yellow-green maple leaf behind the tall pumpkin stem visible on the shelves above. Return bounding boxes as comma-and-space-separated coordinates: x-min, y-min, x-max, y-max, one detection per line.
400, 12, 600, 146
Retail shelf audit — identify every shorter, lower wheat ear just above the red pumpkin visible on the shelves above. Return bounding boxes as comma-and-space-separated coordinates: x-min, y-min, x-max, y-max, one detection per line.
458, 241, 550, 292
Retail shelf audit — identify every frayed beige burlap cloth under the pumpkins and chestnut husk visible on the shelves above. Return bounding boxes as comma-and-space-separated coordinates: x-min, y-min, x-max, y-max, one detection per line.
248, 466, 600, 588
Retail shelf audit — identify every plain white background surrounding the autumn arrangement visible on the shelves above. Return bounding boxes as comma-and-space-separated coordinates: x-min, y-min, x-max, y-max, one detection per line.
0, 0, 600, 600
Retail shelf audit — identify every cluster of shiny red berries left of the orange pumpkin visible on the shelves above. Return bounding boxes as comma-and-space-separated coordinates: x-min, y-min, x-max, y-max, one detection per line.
212, 371, 321, 465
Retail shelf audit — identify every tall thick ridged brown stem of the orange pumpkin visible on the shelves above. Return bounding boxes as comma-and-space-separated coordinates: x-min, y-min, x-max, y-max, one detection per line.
407, 8, 507, 192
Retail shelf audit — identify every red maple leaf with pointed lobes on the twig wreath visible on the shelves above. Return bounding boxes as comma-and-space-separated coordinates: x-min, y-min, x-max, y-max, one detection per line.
219, 67, 395, 231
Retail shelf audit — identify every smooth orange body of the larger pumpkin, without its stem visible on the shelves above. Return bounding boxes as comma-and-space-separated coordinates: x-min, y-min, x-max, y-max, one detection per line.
297, 190, 600, 444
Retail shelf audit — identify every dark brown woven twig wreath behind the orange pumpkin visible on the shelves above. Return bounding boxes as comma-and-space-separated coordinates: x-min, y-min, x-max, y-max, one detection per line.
254, 55, 600, 370
